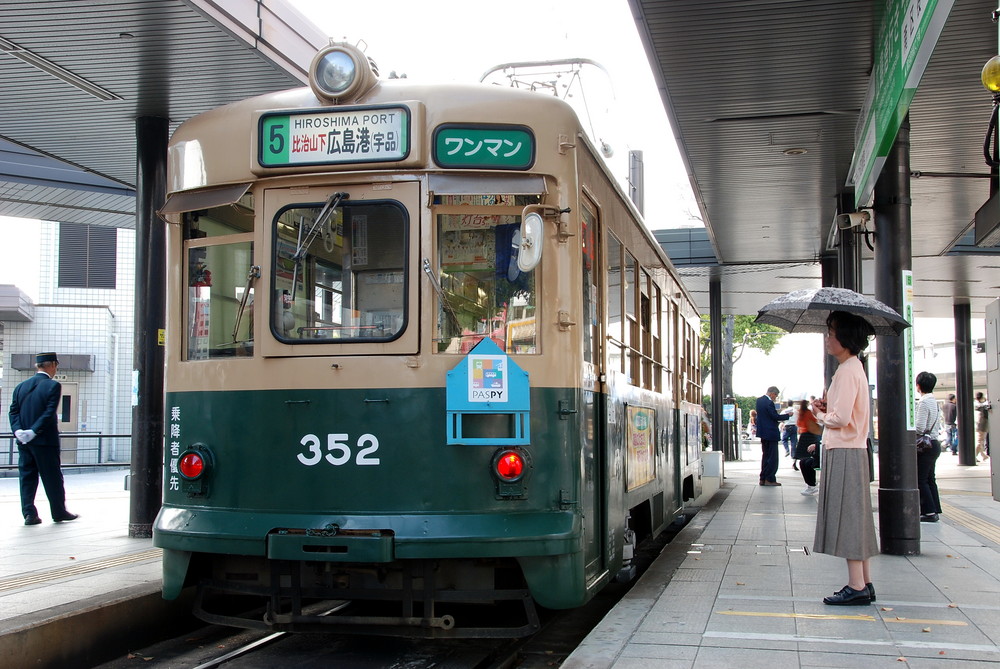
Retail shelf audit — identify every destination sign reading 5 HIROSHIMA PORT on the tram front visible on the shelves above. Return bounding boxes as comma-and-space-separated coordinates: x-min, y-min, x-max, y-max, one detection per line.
257, 107, 410, 167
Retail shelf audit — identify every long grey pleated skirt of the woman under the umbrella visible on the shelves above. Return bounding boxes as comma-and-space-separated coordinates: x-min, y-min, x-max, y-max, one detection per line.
813, 448, 878, 560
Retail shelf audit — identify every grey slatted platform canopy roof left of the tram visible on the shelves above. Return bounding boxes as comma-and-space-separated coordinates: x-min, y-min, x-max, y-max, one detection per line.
0, 0, 328, 228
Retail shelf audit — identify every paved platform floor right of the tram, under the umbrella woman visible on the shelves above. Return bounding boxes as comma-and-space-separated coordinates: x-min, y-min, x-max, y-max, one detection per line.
562, 444, 1000, 669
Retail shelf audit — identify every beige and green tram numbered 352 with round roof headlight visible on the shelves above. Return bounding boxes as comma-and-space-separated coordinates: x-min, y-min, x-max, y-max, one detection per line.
153, 43, 701, 637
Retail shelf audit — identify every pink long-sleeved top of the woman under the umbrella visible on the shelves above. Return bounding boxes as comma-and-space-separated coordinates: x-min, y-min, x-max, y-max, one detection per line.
814, 355, 869, 448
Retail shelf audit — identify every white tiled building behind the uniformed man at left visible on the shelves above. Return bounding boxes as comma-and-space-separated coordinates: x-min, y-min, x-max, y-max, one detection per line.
0, 222, 135, 464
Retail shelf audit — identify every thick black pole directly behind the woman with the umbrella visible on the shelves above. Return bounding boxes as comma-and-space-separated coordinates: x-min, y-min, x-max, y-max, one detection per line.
875, 117, 920, 555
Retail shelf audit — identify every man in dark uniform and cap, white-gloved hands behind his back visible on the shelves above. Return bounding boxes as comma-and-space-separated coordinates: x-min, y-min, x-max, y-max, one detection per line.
10, 353, 78, 525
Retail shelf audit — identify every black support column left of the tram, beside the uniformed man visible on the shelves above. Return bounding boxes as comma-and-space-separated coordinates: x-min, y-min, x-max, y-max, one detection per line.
128, 116, 169, 537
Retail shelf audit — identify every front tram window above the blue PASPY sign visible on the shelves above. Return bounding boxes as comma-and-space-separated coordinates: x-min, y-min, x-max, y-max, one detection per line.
435, 195, 544, 354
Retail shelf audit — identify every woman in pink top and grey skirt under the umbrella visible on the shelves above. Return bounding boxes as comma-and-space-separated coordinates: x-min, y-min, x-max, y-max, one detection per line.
813, 311, 878, 606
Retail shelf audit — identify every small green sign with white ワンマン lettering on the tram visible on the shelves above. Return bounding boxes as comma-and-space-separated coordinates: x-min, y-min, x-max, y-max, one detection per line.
434, 123, 535, 170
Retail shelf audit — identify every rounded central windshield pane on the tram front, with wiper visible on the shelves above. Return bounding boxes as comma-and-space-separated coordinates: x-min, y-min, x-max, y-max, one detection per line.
271, 202, 407, 344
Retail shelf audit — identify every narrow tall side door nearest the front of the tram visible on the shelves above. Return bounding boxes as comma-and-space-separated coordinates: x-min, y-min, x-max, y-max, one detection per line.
580, 198, 608, 584
